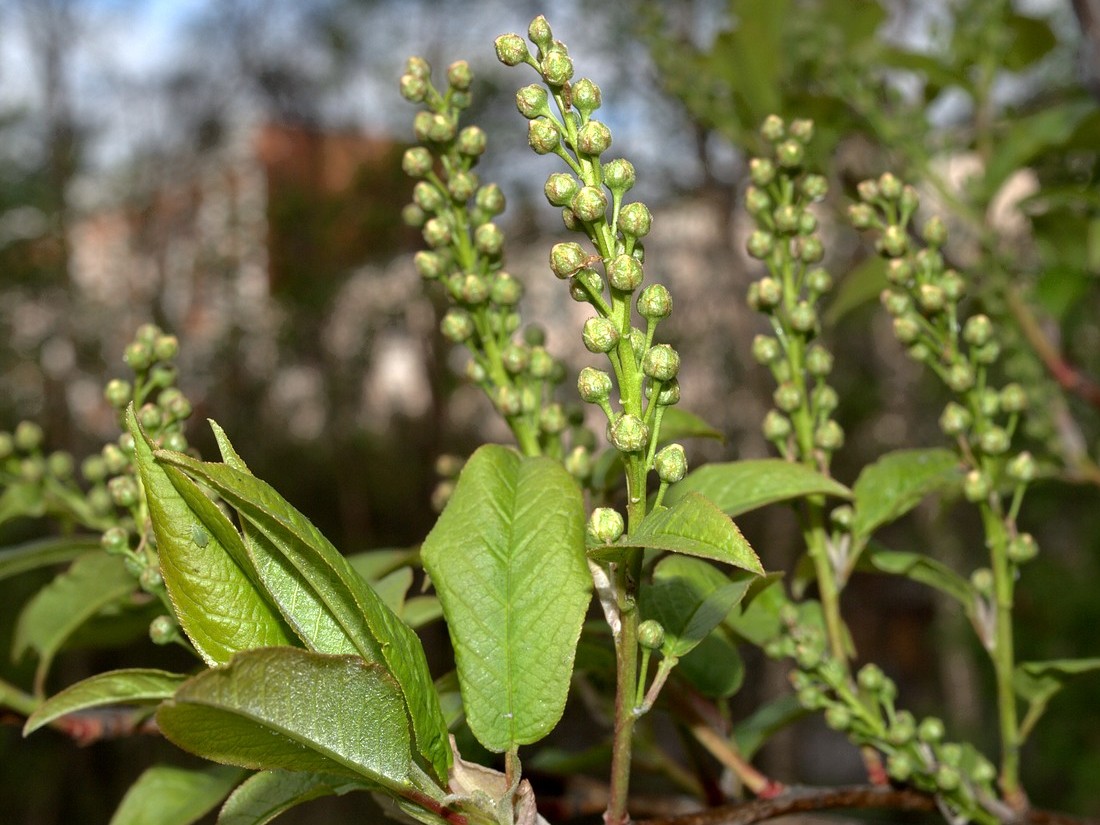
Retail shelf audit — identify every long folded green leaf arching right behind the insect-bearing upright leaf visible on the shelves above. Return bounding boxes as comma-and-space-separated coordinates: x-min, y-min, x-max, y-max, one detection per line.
156, 442, 451, 780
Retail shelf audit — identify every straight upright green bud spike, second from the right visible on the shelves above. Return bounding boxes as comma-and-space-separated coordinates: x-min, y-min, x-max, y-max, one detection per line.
745, 116, 844, 464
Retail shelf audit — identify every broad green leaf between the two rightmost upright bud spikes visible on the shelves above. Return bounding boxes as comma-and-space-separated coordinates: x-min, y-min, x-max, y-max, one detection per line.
851, 449, 963, 543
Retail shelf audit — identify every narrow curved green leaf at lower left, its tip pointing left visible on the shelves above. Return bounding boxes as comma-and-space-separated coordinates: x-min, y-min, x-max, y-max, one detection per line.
23, 668, 187, 736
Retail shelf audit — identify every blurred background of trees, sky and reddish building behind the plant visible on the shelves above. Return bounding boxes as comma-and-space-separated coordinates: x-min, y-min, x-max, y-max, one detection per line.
0, 0, 1100, 825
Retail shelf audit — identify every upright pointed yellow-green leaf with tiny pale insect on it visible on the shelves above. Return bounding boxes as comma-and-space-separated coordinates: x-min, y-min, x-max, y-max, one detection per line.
127, 406, 289, 664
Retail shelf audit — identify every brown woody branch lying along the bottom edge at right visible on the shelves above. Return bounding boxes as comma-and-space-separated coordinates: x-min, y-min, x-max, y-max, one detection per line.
636, 785, 1100, 825
